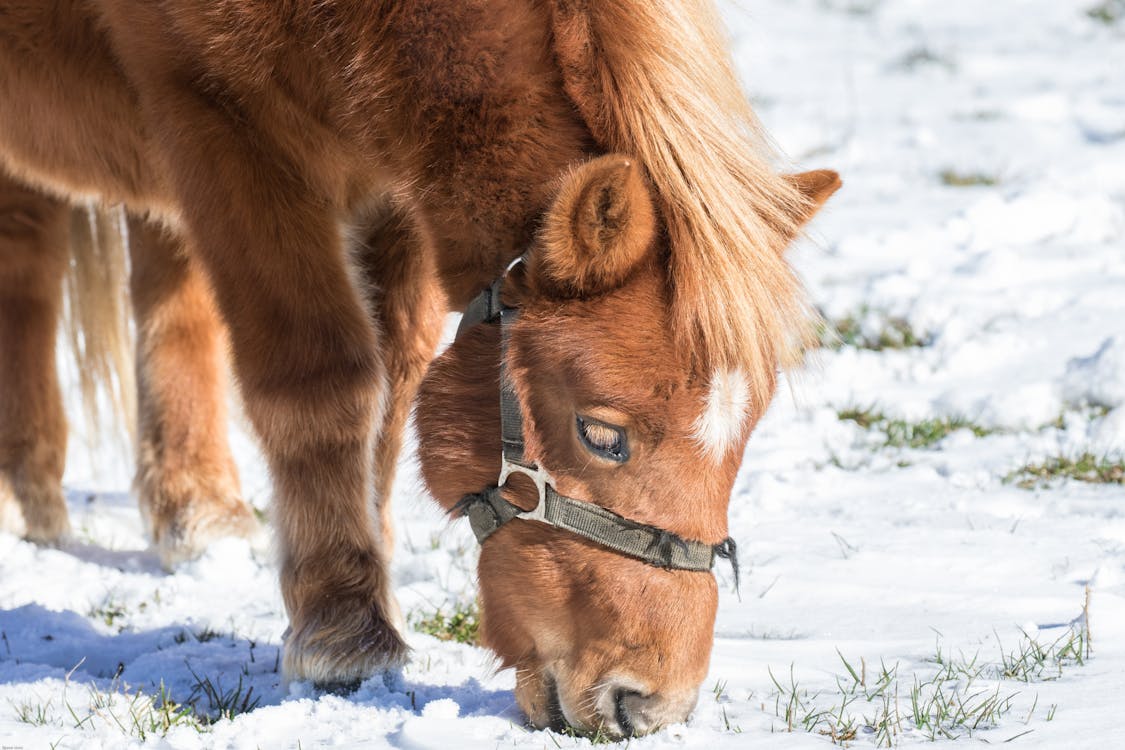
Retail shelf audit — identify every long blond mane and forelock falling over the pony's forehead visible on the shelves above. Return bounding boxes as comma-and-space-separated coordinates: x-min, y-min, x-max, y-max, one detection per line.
551, 0, 812, 406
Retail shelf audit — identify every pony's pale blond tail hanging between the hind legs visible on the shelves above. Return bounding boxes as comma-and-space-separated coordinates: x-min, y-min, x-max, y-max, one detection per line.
65, 206, 136, 445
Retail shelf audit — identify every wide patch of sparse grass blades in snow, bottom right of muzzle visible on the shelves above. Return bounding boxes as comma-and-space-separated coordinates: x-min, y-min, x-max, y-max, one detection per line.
763, 629, 1089, 748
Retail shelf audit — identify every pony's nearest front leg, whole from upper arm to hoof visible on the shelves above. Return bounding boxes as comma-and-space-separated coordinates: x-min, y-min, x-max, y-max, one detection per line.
142, 118, 406, 684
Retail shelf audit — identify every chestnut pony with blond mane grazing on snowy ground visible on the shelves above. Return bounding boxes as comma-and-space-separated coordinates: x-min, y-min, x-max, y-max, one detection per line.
0, 0, 839, 735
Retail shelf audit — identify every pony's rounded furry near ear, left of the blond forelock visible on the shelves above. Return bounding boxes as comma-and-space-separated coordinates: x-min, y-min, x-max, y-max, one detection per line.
531, 154, 656, 297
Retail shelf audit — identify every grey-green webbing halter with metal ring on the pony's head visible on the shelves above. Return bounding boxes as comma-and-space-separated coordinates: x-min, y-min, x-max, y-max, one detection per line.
455, 256, 738, 590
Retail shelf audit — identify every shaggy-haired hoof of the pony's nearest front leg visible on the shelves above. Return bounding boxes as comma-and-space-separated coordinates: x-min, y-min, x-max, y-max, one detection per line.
282, 597, 410, 693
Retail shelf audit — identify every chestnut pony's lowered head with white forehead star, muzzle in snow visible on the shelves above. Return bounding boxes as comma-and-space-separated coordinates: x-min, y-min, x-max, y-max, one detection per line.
416, 154, 839, 737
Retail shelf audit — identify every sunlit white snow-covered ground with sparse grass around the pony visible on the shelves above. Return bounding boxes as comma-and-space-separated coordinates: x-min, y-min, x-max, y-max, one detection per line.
0, 0, 1125, 749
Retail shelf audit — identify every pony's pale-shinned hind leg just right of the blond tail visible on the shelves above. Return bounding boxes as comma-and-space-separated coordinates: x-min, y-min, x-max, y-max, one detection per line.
128, 216, 259, 567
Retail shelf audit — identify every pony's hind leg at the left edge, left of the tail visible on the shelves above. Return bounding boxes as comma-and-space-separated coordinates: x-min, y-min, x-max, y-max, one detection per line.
0, 174, 69, 542
